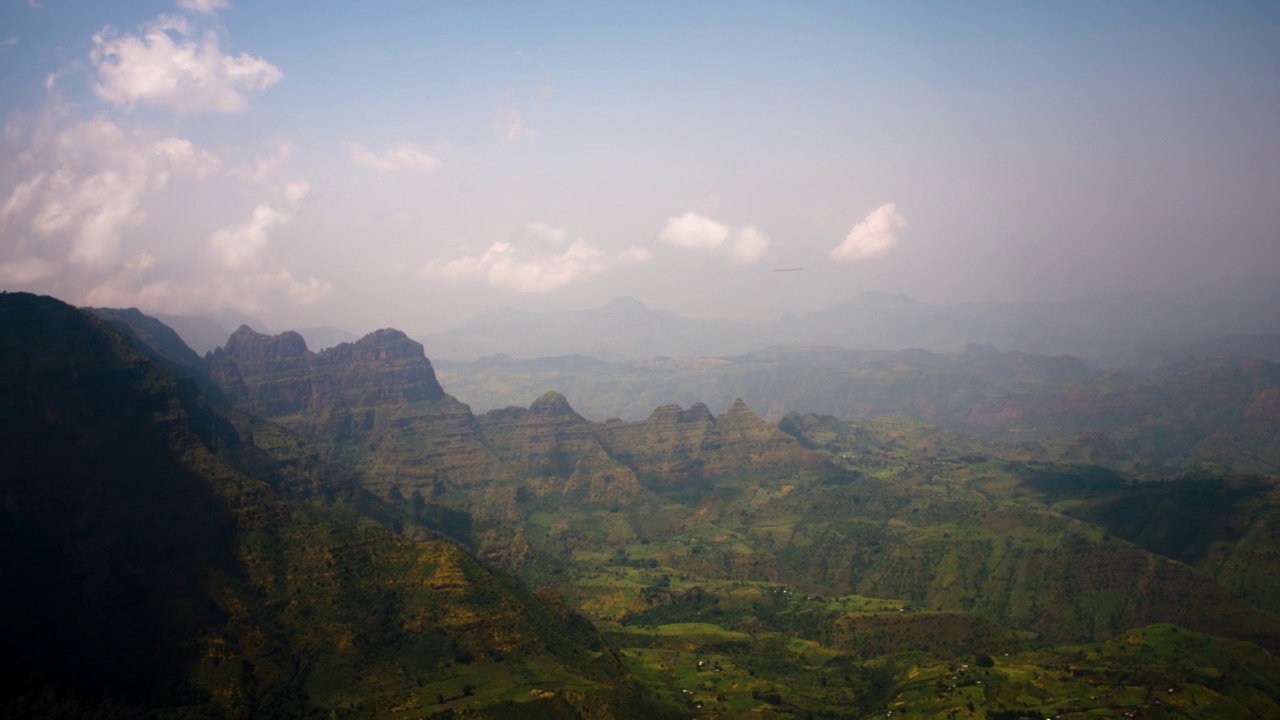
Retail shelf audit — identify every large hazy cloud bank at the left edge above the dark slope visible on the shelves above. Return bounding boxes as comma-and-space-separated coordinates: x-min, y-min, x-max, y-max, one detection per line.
0, 106, 333, 313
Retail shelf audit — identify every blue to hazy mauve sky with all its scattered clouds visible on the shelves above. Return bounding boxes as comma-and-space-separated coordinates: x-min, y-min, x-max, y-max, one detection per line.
0, 0, 1280, 333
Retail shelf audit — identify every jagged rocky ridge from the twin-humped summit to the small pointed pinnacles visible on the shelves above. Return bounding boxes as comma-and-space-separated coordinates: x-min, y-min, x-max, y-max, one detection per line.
210, 327, 824, 515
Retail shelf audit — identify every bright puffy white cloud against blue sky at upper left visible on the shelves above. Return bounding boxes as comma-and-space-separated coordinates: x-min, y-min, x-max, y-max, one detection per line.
90, 14, 284, 113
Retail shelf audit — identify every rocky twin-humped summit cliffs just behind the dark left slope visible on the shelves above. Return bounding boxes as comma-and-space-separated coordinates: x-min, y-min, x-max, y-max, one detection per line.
210, 325, 444, 418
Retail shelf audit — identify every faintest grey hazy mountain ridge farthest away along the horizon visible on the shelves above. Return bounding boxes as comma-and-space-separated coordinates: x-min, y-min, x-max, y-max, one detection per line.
419, 283, 1280, 361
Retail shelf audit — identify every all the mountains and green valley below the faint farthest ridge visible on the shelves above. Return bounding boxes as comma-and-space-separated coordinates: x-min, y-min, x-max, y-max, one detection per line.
0, 293, 1280, 719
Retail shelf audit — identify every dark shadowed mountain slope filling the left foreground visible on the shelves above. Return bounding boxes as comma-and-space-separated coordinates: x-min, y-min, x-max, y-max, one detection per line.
0, 293, 652, 717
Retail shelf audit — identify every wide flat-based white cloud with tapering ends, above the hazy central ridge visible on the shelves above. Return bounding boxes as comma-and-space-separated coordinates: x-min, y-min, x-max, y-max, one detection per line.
417, 222, 649, 292
